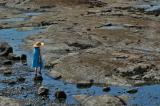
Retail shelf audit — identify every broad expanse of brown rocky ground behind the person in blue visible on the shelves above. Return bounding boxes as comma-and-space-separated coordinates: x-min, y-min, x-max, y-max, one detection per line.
0, 0, 160, 105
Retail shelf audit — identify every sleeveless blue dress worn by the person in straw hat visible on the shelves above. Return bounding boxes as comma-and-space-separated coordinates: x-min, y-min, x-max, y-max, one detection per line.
32, 47, 43, 68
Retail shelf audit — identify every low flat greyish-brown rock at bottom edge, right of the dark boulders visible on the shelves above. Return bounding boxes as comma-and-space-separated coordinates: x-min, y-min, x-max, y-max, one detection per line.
74, 94, 126, 106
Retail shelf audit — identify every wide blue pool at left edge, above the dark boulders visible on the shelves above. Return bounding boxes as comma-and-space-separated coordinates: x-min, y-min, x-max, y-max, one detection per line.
0, 28, 42, 54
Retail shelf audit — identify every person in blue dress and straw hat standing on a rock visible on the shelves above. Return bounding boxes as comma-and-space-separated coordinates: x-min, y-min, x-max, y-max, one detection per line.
32, 42, 44, 76
